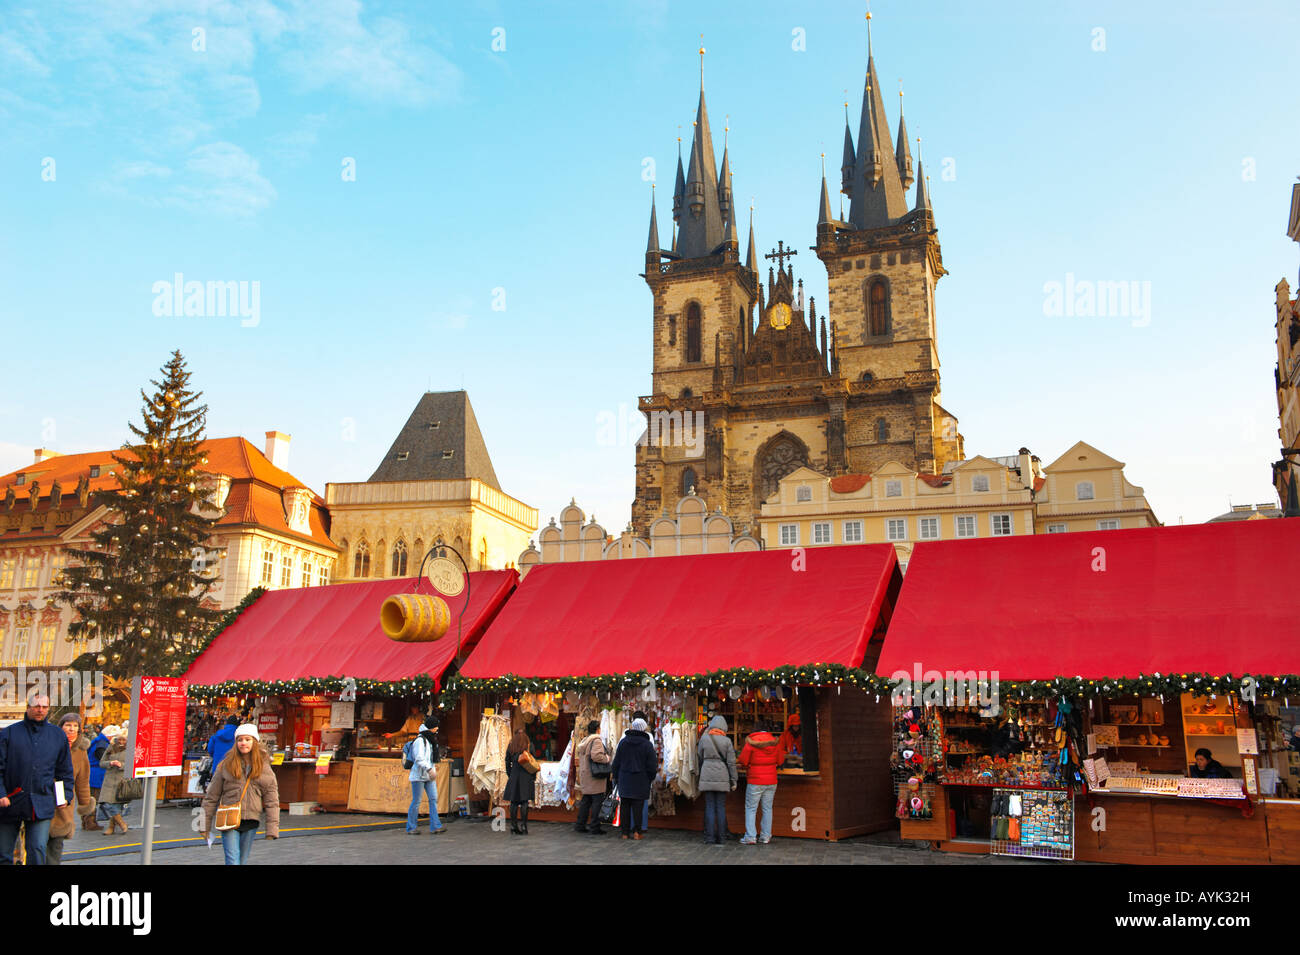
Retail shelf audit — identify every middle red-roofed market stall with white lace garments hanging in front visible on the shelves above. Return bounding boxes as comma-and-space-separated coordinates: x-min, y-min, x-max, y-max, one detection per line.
443, 544, 901, 839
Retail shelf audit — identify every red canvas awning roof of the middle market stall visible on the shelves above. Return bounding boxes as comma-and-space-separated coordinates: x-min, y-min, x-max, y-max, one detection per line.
460, 544, 900, 678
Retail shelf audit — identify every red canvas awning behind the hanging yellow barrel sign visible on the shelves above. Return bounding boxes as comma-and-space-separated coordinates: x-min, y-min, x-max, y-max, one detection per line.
185, 570, 519, 686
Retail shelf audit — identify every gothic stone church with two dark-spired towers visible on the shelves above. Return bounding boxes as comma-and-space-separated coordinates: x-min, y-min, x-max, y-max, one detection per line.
632, 27, 963, 534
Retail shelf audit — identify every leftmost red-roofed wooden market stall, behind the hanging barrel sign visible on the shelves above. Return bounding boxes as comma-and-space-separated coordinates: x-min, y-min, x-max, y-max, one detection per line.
186, 570, 519, 812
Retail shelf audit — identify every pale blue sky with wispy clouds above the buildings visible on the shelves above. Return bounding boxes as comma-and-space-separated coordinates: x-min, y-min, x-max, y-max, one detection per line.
0, 0, 1300, 531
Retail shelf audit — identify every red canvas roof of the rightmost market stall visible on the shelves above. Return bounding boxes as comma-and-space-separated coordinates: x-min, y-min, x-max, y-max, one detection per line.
876, 518, 1300, 681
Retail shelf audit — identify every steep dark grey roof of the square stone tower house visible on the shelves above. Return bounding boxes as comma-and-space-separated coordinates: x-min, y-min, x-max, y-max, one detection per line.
371, 391, 501, 491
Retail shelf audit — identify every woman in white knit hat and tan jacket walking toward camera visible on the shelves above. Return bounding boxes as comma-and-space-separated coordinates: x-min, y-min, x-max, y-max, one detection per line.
202, 722, 280, 865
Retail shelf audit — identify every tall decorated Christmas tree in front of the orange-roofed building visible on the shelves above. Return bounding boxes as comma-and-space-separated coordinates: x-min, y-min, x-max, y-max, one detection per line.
60, 351, 221, 677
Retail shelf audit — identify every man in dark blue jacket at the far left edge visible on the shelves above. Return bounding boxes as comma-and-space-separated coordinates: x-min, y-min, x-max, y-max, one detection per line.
0, 694, 74, 865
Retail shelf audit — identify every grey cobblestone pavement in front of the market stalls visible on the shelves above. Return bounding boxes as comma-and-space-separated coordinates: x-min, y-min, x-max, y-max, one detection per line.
64, 807, 1045, 865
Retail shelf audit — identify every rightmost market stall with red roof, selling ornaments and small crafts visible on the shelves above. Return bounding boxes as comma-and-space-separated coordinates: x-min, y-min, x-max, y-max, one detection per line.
876, 521, 1300, 863
